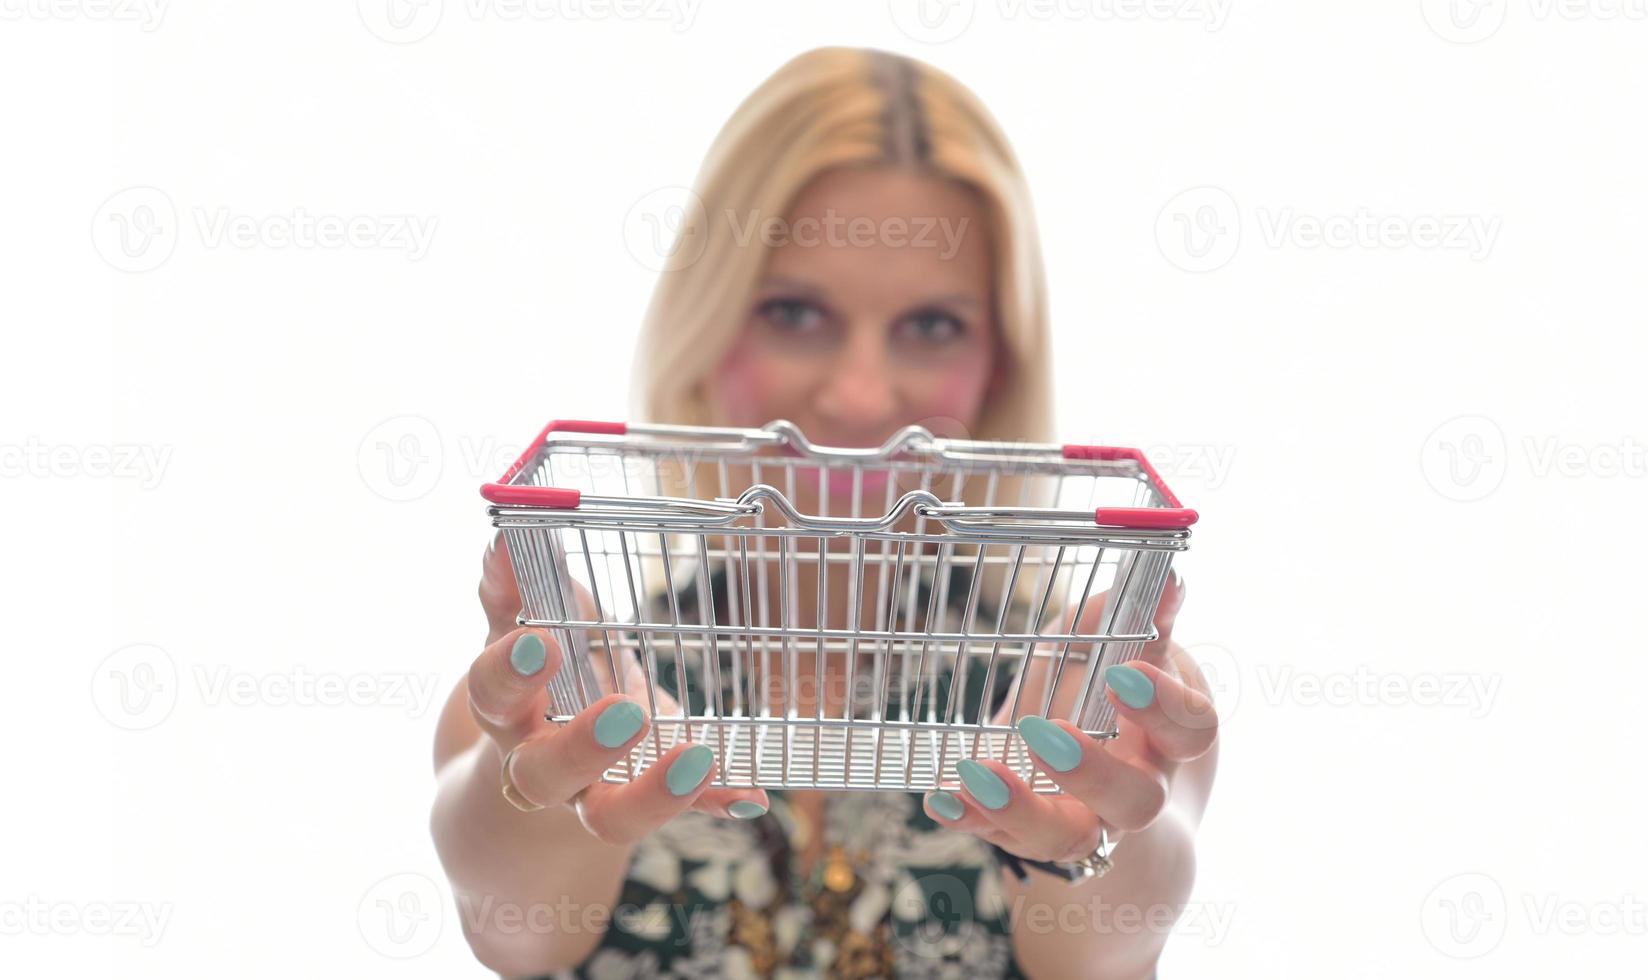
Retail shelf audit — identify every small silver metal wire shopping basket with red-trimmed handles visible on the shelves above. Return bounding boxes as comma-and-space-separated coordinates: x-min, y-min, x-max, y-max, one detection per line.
481, 420, 1196, 792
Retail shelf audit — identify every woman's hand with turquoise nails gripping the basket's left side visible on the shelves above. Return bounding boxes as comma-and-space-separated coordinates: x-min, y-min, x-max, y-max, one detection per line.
468, 535, 768, 845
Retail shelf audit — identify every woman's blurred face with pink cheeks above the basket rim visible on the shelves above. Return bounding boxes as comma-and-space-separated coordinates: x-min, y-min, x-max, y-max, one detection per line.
707, 170, 997, 457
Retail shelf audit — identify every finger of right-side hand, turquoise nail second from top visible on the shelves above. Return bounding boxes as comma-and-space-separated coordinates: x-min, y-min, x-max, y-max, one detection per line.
1018, 715, 1168, 830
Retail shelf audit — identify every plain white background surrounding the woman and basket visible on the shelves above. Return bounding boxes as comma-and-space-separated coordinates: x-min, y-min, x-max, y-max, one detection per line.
0, 0, 1648, 977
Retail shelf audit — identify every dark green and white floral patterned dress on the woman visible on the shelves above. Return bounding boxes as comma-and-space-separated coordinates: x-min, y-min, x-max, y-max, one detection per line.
537, 563, 1023, 980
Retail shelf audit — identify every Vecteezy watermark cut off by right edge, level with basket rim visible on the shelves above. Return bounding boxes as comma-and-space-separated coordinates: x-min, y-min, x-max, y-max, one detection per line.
1419, 415, 1648, 502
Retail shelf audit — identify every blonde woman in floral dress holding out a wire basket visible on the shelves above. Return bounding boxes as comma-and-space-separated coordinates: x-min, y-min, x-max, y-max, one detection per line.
432, 49, 1216, 978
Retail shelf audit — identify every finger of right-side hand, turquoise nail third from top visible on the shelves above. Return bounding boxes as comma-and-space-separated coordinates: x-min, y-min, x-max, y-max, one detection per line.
956, 759, 1099, 861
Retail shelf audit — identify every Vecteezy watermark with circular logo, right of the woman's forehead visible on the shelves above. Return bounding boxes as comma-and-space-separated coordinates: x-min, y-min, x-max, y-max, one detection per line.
1155, 186, 1503, 272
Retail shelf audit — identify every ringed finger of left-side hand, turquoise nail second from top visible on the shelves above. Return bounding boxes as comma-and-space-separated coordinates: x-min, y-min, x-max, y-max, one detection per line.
509, 695, 649, 807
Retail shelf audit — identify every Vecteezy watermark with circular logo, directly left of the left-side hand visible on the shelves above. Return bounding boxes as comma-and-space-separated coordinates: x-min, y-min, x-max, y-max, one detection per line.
92, 644, 440, 731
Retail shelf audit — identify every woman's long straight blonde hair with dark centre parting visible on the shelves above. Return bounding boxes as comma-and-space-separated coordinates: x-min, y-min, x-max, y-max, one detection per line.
634, 48, 1053, 441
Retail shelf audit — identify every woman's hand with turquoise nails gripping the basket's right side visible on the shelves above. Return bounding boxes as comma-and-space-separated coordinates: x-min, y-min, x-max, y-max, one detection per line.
925, 576, 1218, 861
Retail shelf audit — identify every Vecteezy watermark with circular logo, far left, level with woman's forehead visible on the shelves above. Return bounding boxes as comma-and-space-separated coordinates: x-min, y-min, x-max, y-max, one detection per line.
92, 186, 437, 272
